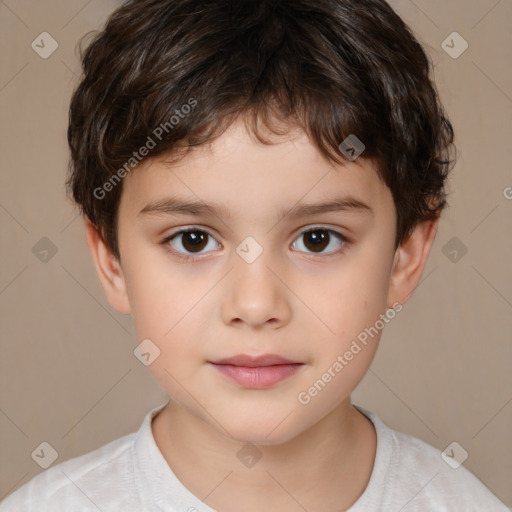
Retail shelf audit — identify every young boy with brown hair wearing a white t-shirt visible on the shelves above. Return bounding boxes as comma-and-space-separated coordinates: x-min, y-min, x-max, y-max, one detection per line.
0, 0, 508, 512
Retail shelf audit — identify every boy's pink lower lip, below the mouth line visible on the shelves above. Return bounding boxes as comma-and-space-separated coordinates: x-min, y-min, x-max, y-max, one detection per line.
212, 363, 303, 389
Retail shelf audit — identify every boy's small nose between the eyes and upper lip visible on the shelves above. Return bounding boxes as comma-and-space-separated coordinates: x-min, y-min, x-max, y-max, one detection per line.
221, 246, 291, 329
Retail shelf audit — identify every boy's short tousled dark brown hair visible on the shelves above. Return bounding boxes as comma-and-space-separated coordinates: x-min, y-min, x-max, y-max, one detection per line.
66, 0, 454, 259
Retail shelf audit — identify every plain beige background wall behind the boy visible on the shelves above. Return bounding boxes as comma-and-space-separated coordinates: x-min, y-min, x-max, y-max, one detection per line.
0, 0, 512, 506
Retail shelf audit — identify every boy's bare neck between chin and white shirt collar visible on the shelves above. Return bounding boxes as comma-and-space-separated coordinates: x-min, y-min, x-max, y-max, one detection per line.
152, 398, 376, 512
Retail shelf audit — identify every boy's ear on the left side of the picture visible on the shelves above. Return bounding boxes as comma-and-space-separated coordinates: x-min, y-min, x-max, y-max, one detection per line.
84, 216, 131, 314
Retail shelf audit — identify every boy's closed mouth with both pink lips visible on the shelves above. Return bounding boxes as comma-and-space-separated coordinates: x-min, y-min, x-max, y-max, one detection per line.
209, 354, 304, 389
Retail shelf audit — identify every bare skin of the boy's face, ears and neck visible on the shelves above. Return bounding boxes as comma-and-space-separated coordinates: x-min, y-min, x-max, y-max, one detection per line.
85, 121, 438, 512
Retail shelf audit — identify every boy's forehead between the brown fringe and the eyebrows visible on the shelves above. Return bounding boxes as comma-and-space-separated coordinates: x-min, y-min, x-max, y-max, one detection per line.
120, 122, 391, 223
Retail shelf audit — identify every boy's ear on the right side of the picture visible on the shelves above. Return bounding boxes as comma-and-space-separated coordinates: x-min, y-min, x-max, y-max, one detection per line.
387, 217, 439, 308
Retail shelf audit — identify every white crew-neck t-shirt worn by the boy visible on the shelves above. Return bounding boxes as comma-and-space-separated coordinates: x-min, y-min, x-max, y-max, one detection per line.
0, 404, 509, 512
